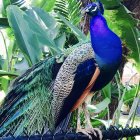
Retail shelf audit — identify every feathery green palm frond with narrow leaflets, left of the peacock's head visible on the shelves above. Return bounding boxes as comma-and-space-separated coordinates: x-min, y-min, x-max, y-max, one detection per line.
54, 0, 81, 47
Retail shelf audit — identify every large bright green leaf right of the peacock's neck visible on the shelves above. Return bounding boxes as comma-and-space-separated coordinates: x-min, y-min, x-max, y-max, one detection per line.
105, 5, 140, 70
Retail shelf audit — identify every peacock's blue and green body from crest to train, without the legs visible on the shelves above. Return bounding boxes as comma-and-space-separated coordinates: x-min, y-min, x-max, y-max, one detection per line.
0, 2, 122, 139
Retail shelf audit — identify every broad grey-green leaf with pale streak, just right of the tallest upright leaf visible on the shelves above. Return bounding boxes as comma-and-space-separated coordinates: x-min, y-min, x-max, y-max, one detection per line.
26, 8, 61, 55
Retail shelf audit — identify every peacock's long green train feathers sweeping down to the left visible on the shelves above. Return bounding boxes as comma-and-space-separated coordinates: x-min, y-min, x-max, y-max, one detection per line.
0, 58, 55, 136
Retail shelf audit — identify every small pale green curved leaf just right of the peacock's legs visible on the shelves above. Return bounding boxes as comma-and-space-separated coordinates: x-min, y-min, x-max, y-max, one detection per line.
87, 98, 110, 113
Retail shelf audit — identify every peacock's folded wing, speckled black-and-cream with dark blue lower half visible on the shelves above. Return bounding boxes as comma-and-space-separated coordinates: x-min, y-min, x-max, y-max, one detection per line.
51, 43, 96, 126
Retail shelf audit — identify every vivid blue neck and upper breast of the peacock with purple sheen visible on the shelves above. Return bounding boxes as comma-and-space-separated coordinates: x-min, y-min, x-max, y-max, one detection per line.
90, 15, 122, 65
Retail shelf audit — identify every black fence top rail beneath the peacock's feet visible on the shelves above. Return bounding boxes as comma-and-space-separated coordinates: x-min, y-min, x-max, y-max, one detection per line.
0, 126, 140, 140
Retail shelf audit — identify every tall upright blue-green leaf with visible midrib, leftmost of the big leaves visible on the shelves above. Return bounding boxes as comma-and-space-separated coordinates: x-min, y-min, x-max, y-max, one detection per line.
7, 5, 41, 65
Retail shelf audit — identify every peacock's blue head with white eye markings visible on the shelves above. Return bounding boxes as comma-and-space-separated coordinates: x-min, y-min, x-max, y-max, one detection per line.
84, 1, 104, 16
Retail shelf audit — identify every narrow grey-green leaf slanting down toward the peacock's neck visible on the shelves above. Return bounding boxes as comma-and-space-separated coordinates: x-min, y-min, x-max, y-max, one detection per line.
58, 13, 87, 40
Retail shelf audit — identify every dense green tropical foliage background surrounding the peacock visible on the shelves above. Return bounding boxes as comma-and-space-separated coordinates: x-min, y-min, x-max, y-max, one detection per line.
0, 0, 140, 139
